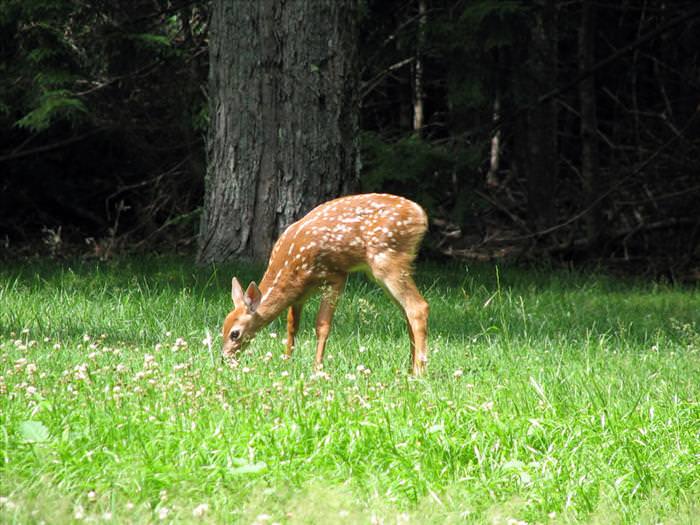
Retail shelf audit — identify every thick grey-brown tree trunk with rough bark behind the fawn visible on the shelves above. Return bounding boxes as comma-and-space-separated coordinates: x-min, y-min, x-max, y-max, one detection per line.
199, 0, 359, 262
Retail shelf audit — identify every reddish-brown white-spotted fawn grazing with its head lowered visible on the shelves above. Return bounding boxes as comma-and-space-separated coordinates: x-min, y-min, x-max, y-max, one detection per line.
222, 193, 428, 375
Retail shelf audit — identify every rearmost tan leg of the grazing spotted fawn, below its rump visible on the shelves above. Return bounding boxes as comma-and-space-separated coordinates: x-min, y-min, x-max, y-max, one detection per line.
370, 257, 429, 376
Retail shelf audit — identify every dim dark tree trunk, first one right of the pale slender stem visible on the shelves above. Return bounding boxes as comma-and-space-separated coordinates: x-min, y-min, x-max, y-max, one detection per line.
527, 0, 559, 230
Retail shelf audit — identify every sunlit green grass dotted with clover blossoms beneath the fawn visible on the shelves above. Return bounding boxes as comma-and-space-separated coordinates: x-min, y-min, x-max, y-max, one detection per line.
0, 258, 700, 524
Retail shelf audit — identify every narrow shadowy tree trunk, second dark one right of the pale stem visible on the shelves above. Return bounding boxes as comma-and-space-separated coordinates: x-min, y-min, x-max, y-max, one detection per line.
578, 0, 601, 247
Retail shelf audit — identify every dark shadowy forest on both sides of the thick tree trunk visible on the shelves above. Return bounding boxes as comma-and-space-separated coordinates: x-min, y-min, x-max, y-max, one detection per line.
0, 0, 700, 281
